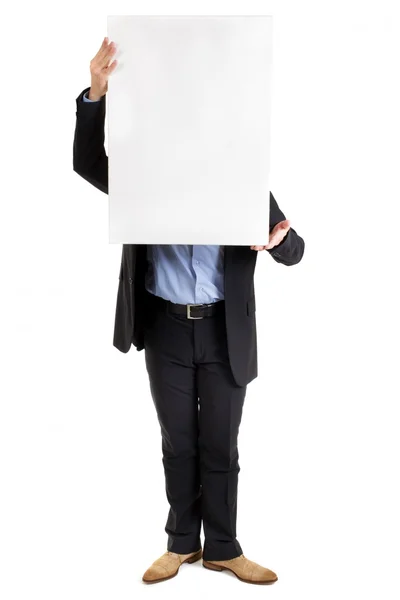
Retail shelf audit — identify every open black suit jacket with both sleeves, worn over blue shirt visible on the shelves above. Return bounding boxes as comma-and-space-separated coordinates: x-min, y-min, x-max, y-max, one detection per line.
73, 88, 304, 386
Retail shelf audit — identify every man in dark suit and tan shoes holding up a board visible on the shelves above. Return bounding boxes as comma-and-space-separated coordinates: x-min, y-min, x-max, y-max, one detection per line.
73, 38, 304, 584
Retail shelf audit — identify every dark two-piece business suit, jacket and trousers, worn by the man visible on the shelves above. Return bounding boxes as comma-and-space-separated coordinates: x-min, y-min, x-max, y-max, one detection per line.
73, 88, 304, 560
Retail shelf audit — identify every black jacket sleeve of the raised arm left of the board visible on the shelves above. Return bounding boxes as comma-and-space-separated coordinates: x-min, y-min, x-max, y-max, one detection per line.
73, 87, 108, 194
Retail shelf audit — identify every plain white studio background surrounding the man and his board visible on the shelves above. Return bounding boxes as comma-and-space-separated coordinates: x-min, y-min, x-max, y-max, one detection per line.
0, 0, 400, 600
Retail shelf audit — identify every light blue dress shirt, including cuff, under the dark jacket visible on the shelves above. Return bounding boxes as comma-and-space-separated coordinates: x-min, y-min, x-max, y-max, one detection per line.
83, 92, 225, 304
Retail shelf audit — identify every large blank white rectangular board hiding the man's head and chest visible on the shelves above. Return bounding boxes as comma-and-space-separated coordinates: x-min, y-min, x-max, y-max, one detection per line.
107, 16, 272, 245
